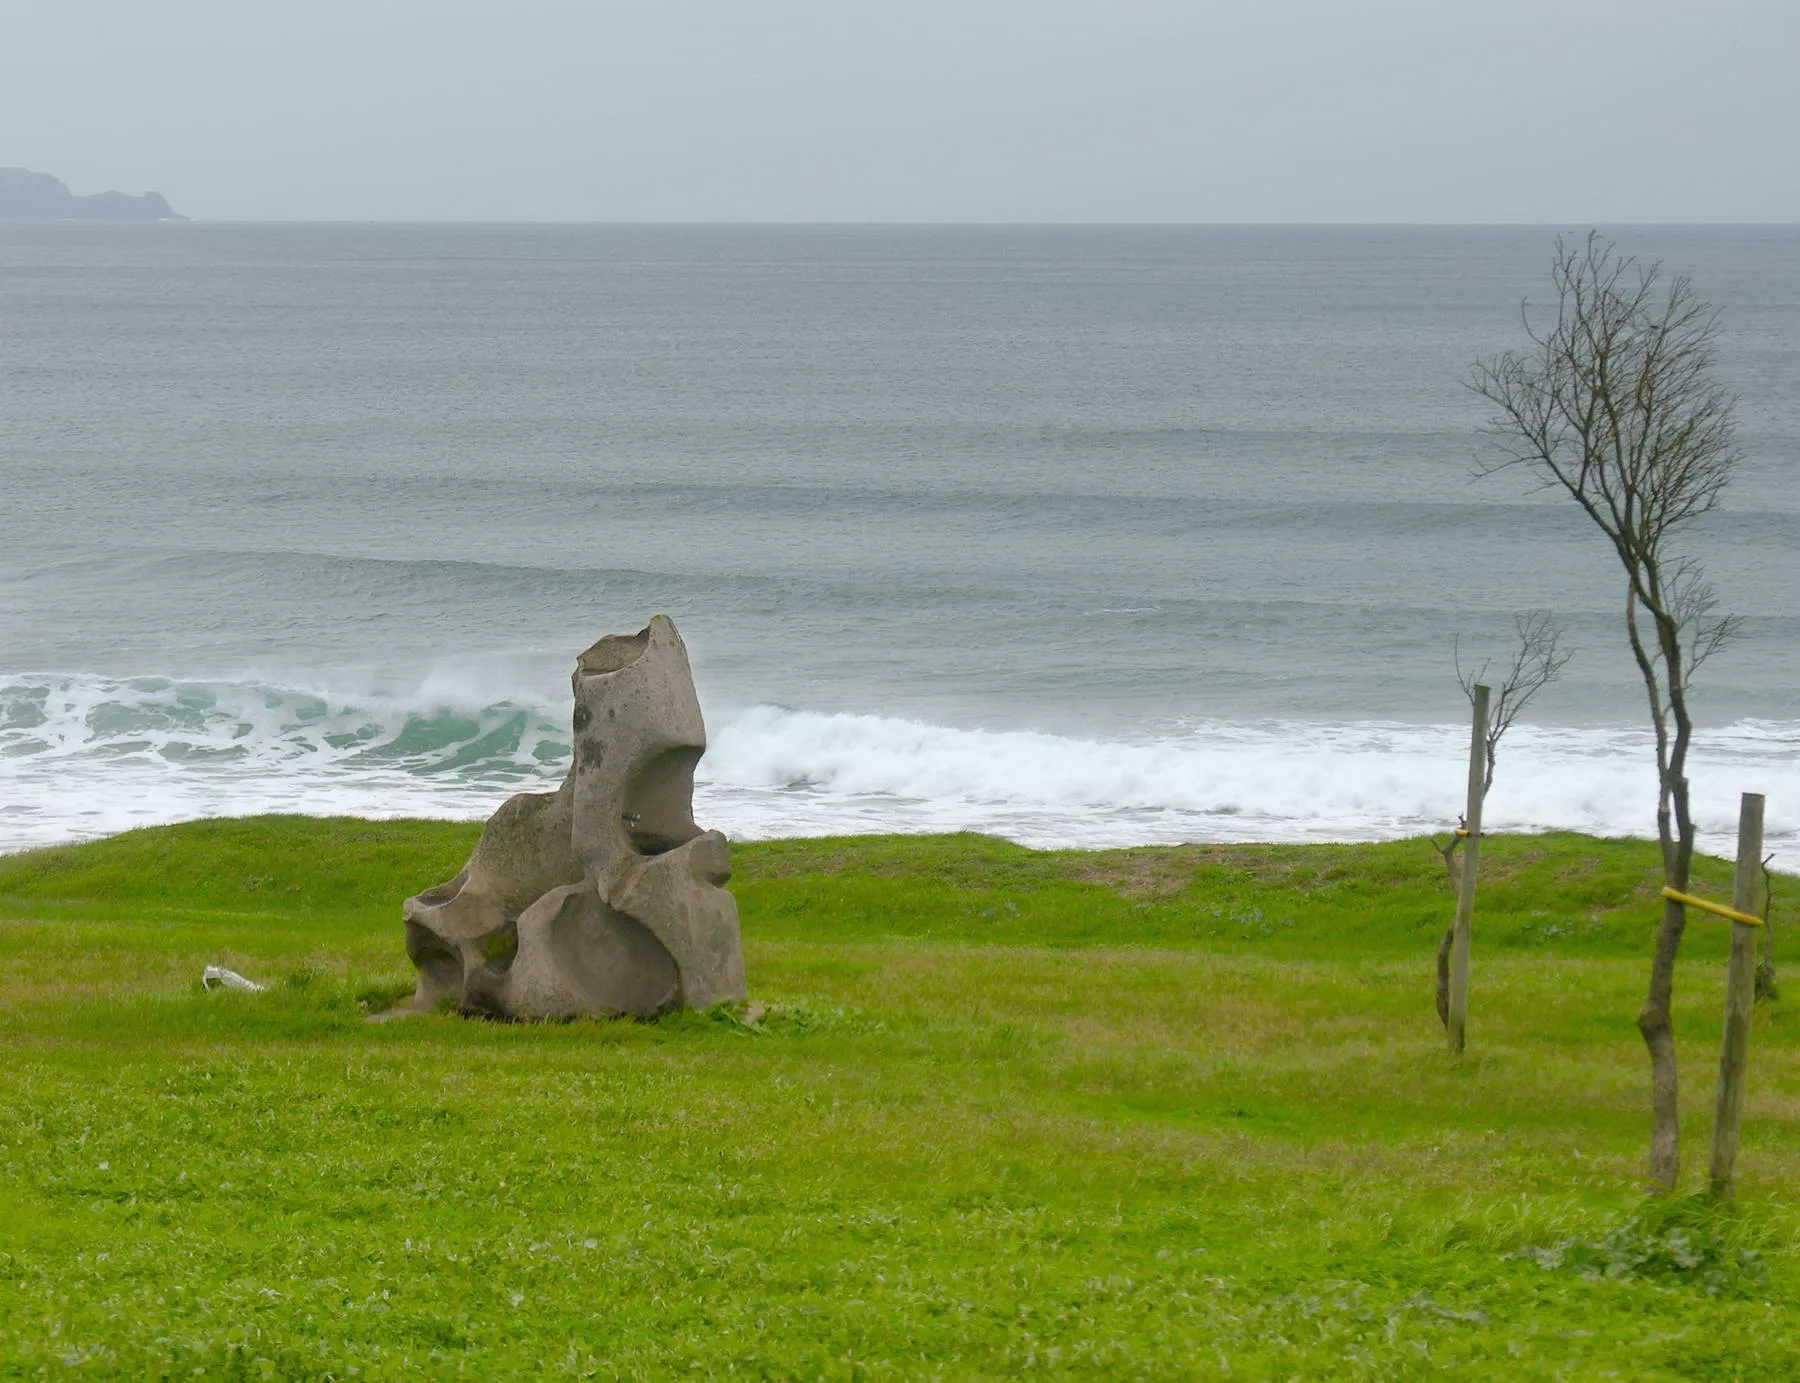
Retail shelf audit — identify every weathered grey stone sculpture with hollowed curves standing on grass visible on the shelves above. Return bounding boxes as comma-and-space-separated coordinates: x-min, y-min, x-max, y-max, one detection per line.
392, 614, 743, 1017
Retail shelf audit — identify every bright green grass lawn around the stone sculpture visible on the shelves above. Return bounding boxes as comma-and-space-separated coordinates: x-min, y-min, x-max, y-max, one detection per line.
0, 818, 1800, 1379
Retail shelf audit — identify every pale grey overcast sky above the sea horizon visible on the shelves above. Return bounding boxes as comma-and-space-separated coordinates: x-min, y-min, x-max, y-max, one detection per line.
0, 0, 1800, 225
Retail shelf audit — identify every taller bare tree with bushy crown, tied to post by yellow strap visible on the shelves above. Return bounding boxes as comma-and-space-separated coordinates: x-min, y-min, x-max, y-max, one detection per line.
1471, 234, 1739, 1189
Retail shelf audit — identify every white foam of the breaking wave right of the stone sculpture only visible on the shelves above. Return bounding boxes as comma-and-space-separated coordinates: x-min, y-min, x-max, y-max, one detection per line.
706, 706, 1800, 863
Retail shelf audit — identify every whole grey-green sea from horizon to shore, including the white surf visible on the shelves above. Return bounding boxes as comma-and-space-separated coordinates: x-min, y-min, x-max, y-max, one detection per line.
0, 223, 1800, 866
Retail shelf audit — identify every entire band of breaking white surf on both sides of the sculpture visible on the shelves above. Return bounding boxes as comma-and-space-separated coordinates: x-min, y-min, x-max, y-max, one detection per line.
0, 675, 1800, 866
